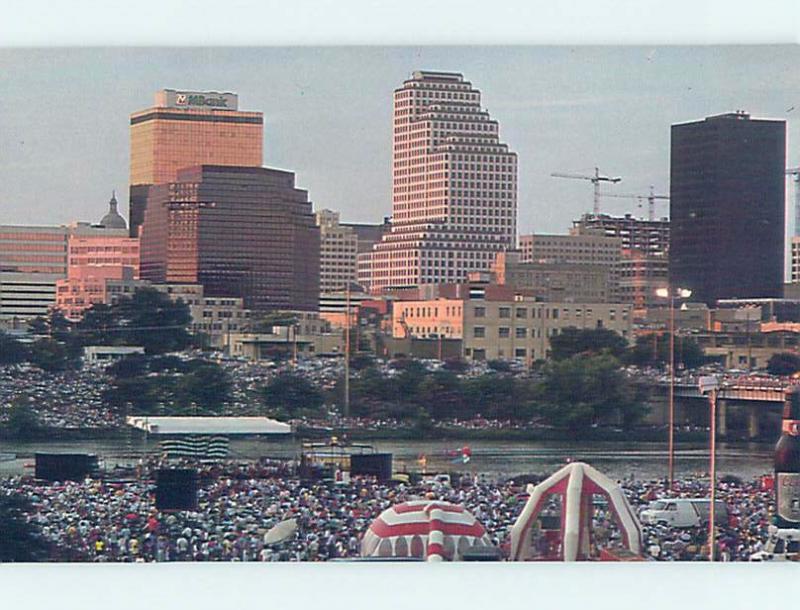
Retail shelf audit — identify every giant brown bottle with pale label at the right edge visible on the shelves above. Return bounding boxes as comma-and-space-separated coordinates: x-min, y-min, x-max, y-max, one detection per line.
775, 386, 800, 529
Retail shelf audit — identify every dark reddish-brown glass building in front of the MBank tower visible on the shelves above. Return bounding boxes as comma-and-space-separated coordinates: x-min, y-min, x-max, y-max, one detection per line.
141, 165, 319, 311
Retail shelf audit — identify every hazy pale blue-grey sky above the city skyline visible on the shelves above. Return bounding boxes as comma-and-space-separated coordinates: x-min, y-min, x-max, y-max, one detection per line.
0, 46, 800, 233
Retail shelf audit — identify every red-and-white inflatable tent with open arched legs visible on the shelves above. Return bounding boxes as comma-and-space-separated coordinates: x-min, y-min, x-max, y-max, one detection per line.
511, 462, 642, 561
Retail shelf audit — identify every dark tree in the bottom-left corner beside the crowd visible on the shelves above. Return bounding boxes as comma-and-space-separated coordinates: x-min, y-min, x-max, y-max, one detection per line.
0, 494, 49, 563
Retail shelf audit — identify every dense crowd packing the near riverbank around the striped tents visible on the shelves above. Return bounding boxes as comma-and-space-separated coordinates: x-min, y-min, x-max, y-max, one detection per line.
0, 463, 772, 562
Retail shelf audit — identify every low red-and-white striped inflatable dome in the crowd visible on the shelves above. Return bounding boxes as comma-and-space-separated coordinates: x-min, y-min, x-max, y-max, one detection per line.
361, 500, 492, 561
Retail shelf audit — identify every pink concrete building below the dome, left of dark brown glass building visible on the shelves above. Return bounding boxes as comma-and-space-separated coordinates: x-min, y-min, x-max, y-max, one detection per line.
56, 234, 139, 321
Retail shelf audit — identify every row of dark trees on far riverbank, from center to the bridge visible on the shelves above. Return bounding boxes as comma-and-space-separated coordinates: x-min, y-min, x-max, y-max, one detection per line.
264, 353, 648, 432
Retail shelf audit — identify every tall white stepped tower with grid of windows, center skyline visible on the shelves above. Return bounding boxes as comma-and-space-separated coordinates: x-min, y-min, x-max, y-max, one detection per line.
362, 72, 517, 292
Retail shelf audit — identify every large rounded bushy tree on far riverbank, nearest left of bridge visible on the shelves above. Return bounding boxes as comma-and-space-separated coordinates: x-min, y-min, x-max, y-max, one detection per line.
540, 354, 646, 433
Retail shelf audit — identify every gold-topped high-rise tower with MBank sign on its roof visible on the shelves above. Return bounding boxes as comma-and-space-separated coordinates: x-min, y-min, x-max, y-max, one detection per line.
129, 89, 264, 237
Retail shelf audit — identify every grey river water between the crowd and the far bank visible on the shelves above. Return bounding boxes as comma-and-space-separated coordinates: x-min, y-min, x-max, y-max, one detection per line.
0, 438, 773, 479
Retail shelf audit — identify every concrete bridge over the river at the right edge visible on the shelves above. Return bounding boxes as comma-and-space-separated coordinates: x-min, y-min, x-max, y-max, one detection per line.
656, 376, 797, 440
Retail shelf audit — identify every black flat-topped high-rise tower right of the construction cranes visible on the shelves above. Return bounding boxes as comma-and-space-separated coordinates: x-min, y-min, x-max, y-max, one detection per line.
669, 111, 786, 306
